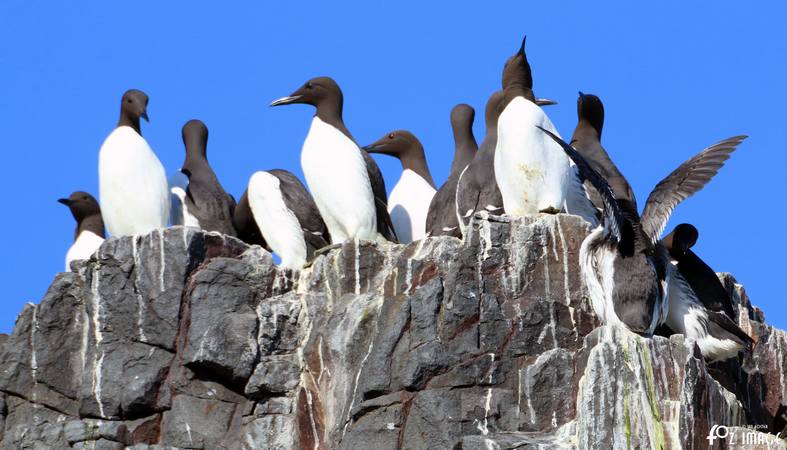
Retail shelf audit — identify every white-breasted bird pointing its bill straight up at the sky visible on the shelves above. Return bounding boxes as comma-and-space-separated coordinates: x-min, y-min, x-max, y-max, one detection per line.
494, 38, 571, 216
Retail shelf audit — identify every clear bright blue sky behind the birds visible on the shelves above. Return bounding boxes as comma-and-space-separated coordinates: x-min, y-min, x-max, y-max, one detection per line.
0, 0, 787, 332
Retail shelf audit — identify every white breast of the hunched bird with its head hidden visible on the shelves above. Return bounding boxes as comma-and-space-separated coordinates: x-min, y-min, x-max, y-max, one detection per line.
248, 171, 307, 269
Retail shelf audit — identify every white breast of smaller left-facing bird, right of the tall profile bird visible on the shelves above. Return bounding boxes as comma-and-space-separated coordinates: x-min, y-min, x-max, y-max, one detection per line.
388, 169, 437, 244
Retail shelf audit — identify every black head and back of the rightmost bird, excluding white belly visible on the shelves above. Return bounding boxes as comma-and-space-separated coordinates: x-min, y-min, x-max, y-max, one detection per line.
661, 223, 736, 320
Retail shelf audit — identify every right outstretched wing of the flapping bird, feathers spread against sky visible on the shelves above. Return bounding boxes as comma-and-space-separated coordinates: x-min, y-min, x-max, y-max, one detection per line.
641, 136, 747, 244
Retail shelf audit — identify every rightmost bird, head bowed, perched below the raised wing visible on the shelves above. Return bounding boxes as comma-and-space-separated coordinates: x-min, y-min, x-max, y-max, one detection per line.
661, 223, 753, 362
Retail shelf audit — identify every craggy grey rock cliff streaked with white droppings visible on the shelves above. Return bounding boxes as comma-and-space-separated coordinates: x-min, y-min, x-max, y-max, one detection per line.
0, 215, 787, 450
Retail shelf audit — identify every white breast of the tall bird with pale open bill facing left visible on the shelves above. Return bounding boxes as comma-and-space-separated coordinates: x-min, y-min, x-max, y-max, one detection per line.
301, 116, 377, 243
